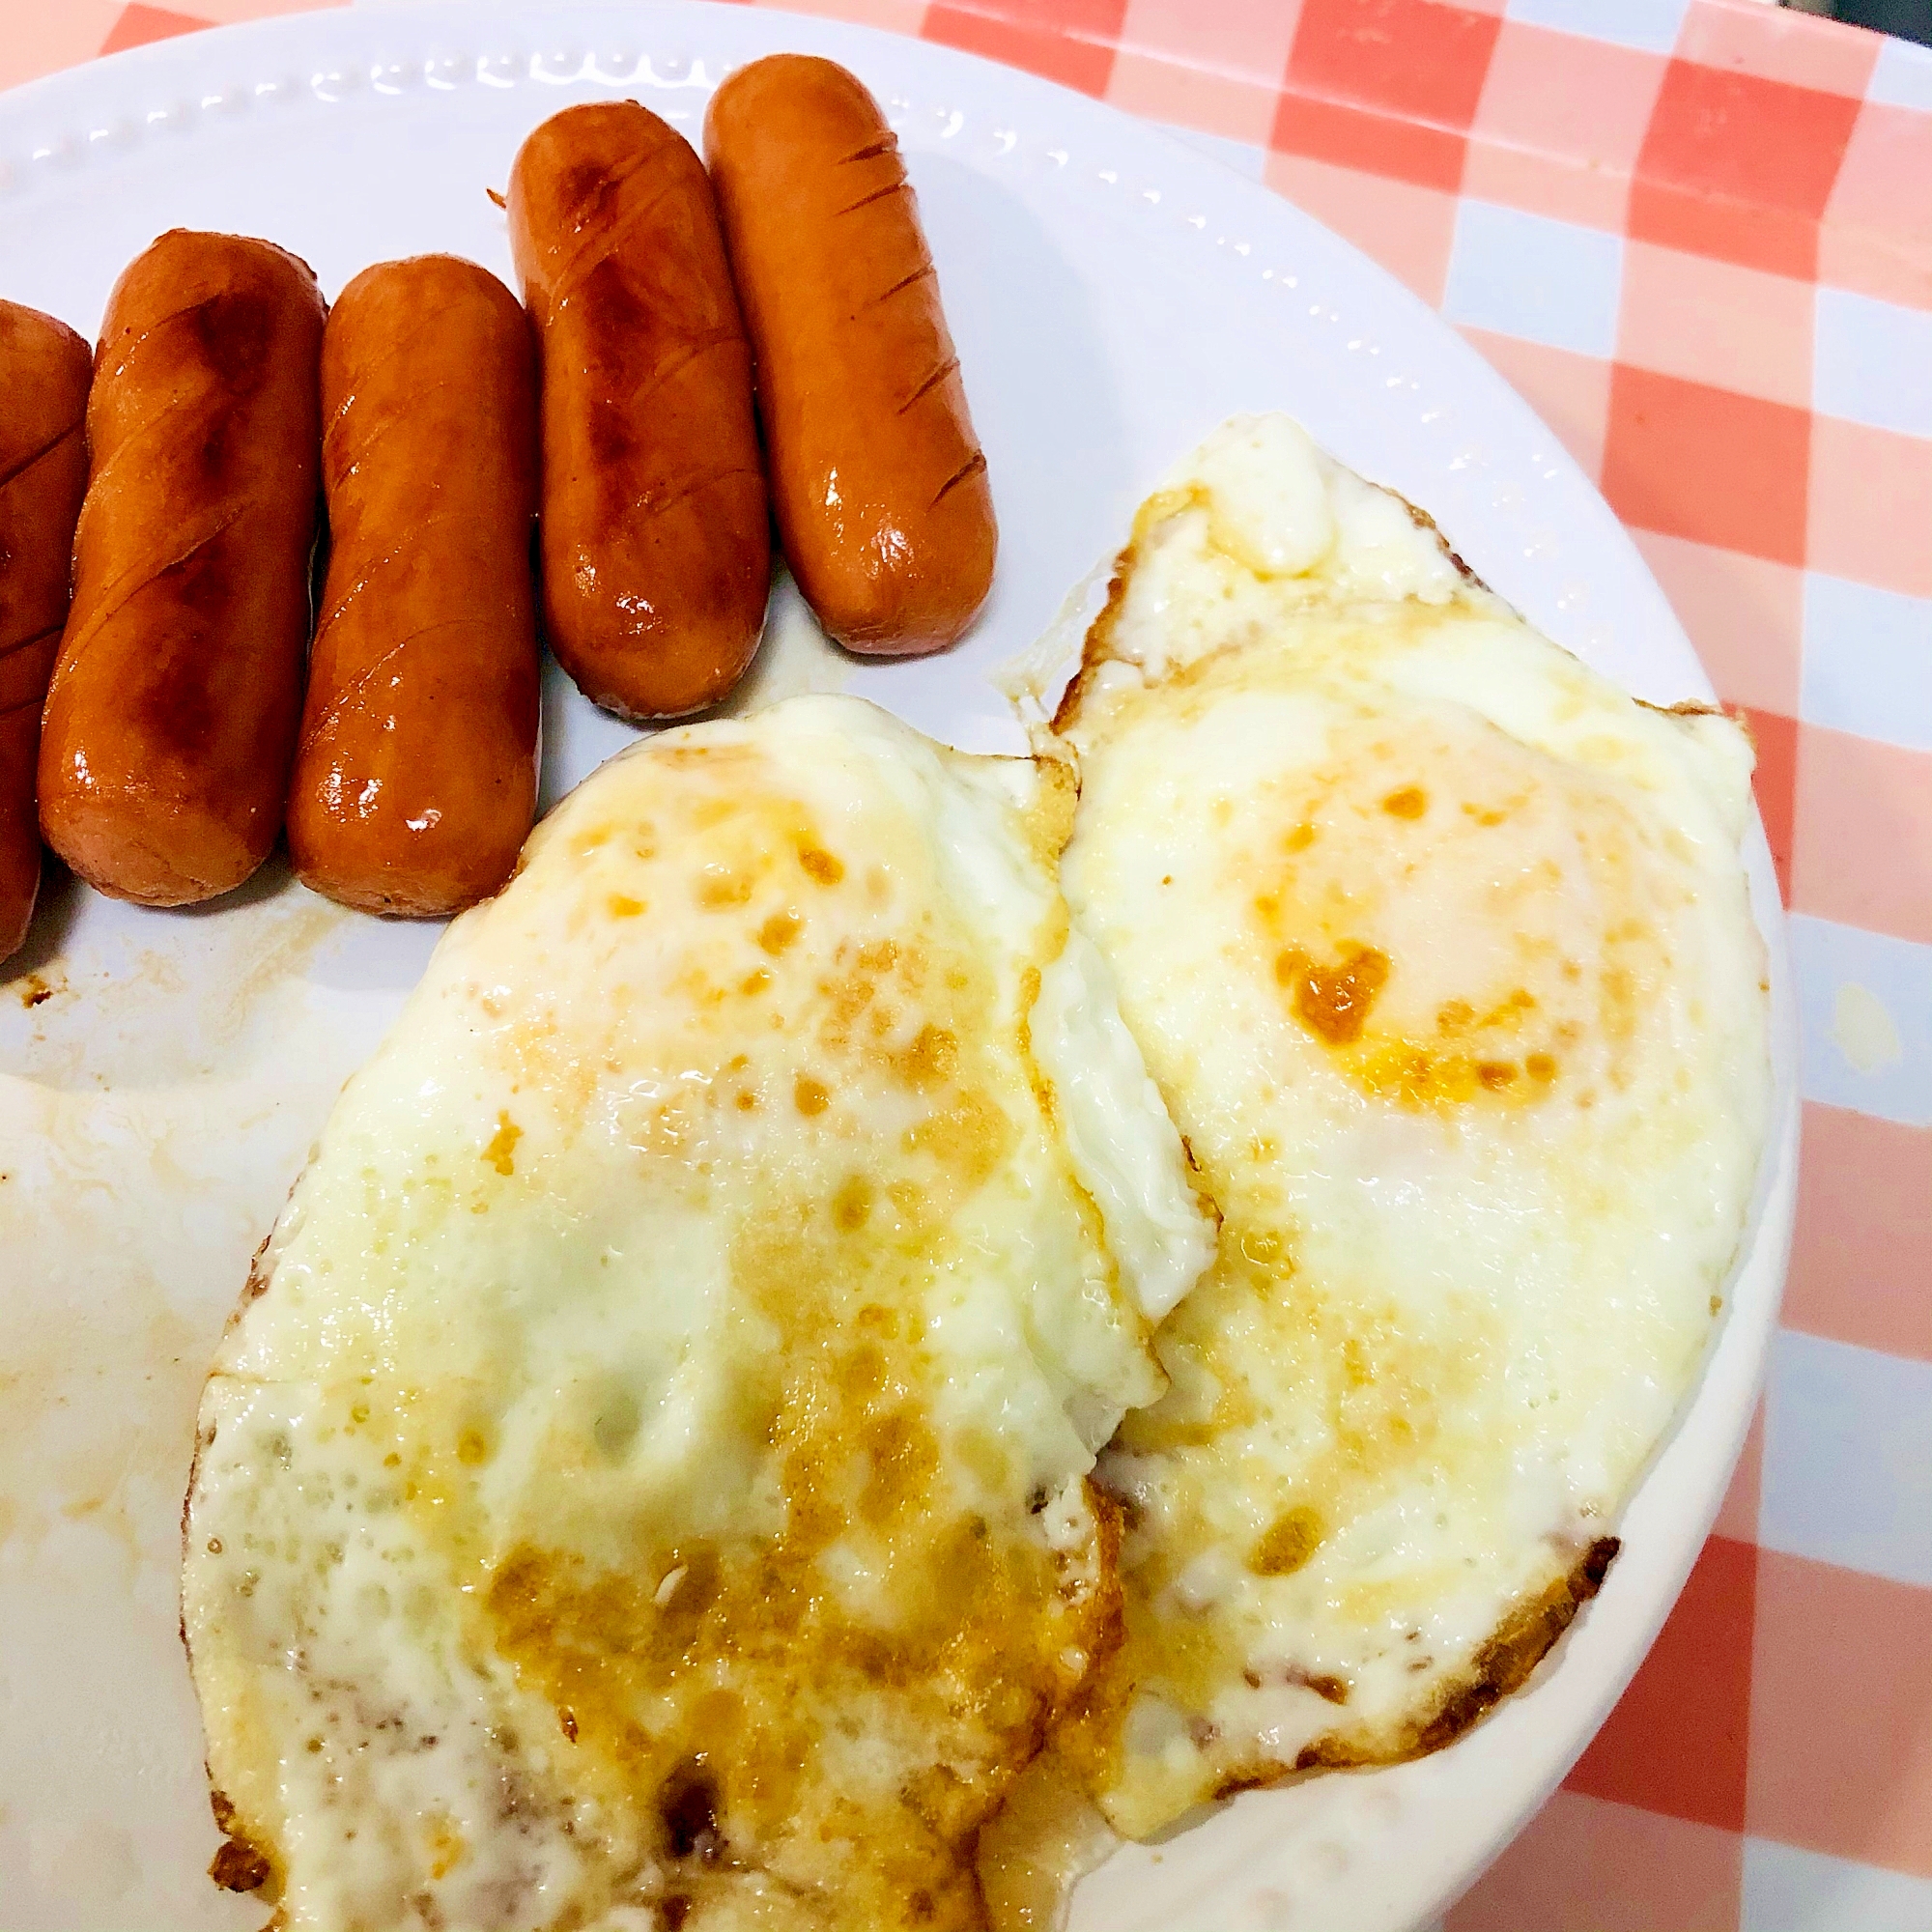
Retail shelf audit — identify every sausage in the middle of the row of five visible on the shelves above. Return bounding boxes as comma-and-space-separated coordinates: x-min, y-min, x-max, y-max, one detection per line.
288, 255, 539, 918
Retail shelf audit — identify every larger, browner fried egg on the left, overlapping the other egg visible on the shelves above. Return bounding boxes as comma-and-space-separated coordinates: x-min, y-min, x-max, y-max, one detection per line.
184, 697, 1213, 1932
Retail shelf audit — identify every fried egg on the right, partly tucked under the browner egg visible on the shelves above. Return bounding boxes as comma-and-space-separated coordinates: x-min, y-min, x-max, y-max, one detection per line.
1055, 415, 1770, 1837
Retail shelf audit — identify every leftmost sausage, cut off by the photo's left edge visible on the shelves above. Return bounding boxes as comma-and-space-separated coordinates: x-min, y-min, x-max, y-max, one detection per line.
0, 301, 95, 960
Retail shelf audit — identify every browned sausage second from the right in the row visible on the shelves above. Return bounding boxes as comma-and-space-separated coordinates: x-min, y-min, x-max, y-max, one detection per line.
508, 100, 771, 719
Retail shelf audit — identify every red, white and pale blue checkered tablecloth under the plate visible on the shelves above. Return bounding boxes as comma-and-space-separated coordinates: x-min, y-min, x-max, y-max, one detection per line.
0, 0, 1932, 1932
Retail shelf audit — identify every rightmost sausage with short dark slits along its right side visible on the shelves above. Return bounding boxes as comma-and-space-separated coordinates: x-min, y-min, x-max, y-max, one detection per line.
705, 54, 999, 657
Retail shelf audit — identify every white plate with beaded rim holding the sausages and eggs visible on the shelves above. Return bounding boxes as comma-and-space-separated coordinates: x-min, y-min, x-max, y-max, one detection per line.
0, 4, 1795, 1932
